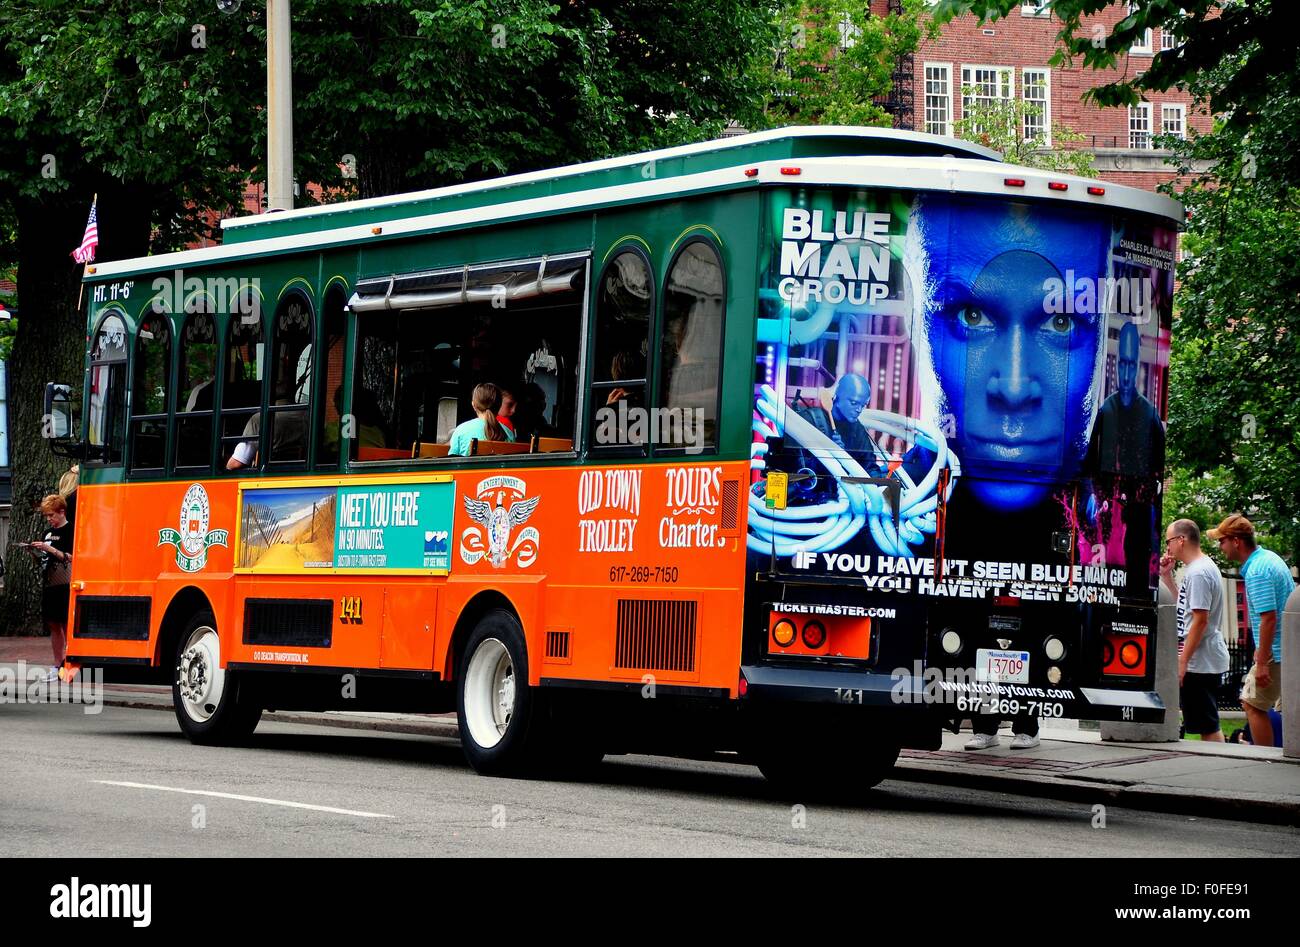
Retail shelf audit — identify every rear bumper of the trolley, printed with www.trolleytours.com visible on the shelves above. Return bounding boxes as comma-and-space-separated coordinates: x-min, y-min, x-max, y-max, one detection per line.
741, 665, 1165, 723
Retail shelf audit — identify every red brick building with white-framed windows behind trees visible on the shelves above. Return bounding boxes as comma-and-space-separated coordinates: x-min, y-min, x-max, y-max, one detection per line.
871, 0, 1210, 190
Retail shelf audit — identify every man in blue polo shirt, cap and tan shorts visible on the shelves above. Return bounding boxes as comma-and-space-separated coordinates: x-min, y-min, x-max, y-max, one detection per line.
1209, 513, 1295, 747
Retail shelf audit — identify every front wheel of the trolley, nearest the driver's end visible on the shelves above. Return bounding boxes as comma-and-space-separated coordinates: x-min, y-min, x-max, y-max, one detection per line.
172, 611, 261, 747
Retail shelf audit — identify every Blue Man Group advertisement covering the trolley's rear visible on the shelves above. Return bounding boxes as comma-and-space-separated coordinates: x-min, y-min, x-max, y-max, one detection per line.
749, 189, 1175, 605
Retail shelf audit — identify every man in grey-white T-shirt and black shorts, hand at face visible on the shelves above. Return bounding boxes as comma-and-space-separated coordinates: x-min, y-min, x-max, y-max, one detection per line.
1160, 519, 1231, 743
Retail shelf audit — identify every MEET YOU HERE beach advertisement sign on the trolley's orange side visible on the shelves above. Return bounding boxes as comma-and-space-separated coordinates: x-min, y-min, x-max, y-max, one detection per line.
235, 477, 455, 575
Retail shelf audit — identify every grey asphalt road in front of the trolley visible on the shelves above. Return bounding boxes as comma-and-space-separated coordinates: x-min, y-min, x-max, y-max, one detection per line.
0, 704, 1300, 857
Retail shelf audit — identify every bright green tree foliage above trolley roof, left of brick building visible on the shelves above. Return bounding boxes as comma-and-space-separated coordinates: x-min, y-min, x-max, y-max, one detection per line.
764, 0, 926, 127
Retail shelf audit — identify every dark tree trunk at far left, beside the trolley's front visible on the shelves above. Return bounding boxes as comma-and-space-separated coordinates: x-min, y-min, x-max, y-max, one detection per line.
0, 195, 90, 635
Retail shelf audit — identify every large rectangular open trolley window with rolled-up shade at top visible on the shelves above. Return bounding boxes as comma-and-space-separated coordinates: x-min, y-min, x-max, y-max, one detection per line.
345, 254, 586, 460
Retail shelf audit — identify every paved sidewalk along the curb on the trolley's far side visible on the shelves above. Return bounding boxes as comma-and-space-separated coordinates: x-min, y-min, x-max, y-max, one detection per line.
0, 637, 1300, 826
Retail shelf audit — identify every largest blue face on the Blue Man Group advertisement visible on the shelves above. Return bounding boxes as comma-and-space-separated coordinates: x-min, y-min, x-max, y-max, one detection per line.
931, 250, 1100, 510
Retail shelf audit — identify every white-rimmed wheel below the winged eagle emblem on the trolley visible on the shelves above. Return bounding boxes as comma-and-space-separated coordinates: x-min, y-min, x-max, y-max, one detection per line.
456, 609, 550, 777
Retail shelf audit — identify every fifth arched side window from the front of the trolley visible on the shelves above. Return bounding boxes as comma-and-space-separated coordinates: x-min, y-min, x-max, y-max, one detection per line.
265, 294, 312, 464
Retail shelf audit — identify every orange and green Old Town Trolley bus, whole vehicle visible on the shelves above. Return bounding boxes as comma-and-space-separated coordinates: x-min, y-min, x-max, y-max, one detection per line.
46, 127, 1180, 790
